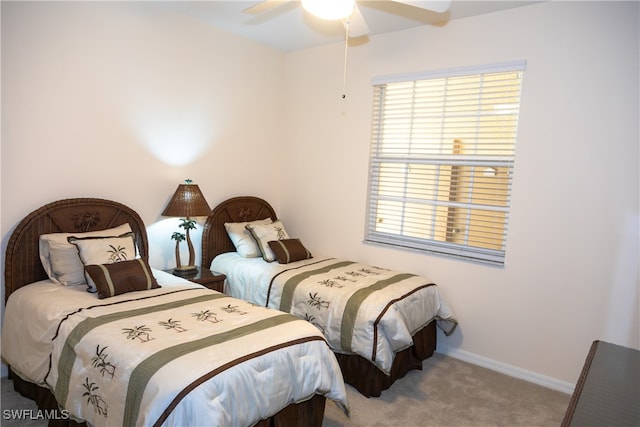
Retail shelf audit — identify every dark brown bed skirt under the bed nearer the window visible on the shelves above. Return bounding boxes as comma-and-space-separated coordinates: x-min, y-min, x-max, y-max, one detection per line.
335, 320, 437, 397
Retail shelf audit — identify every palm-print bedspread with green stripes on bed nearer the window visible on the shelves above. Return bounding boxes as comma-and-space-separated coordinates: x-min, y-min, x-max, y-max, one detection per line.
211, 252, 457, 374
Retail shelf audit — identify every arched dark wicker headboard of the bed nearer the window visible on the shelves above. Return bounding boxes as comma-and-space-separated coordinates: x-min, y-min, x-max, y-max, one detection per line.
200, 196, 278, 268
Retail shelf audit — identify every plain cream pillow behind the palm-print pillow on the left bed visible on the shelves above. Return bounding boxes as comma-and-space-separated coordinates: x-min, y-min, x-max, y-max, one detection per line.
39, 223, 131, 286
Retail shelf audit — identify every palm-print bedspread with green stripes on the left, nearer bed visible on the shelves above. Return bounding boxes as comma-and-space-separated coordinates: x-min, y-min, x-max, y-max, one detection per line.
2, 270, 348, 426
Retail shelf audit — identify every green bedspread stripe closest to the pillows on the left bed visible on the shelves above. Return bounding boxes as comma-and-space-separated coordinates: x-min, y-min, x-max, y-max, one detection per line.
54, 292, 227, 406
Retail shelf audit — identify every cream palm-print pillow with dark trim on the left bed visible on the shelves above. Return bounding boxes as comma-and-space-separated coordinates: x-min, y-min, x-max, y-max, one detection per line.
69, 233, 136, 293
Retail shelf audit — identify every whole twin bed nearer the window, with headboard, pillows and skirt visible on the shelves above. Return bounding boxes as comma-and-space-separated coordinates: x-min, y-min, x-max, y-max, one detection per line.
201, 196, 457, 397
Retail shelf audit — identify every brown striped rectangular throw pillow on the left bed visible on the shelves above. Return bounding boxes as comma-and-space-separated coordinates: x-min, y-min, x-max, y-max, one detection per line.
84, 258, 160, 299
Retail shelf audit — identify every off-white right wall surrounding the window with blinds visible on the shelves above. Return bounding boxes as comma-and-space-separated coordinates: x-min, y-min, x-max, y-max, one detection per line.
280, 2, 640, 391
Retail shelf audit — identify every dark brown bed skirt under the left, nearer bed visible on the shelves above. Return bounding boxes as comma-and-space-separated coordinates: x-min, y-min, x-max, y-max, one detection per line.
9, 367, 326, 427
